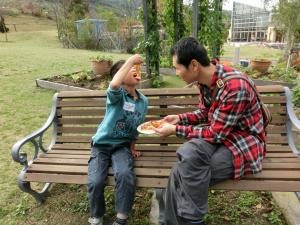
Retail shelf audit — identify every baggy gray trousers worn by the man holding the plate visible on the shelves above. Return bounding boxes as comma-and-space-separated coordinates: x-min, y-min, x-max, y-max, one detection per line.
165, 139, 234, 225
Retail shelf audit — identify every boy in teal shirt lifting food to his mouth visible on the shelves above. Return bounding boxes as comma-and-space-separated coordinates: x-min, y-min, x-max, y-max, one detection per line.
87, 55, 148, 225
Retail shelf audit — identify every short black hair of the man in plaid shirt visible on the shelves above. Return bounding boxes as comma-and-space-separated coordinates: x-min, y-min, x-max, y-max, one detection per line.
171, 37, 210, 68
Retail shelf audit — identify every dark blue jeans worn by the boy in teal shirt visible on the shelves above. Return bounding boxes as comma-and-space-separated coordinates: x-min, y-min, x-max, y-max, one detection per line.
87, 144, 136, 218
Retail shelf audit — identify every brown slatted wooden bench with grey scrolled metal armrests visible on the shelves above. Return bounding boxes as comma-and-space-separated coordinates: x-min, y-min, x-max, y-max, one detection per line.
12, 86, 300, 203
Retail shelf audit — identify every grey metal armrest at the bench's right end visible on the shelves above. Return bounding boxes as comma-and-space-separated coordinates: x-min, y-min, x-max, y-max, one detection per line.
284, 87, 300, 157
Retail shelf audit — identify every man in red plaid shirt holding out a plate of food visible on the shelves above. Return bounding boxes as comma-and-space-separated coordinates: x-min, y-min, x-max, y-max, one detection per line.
156, 37, 265, 225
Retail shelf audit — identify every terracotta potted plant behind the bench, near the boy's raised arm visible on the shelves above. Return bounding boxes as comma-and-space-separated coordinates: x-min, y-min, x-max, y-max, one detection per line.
91, 55, 113, 75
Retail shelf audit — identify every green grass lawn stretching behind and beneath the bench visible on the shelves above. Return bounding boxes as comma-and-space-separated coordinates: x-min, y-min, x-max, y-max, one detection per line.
0, 16, 286, 225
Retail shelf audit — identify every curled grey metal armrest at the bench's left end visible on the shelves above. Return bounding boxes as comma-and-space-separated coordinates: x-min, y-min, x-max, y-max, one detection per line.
11, 94, 57, 168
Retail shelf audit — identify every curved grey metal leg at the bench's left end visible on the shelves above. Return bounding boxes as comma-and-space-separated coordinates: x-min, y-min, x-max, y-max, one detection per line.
18, 169, 51, 204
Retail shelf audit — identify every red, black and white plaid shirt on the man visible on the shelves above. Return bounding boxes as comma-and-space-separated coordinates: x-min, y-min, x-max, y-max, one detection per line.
176, 64, 265, 179
